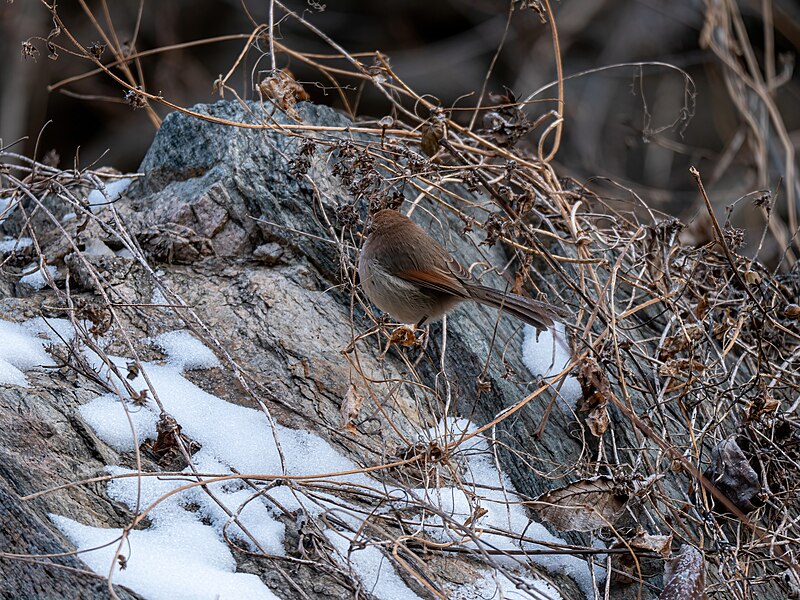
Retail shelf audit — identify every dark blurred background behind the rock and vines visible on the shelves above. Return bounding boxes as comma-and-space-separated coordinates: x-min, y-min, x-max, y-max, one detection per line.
0, 0, 800, 226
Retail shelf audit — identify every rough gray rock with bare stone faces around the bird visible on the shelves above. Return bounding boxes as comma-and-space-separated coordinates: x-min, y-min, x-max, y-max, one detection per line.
0, 102, 780, 599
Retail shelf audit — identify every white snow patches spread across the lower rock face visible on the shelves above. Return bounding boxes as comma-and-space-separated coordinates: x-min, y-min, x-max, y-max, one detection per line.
0, 318, 591, 600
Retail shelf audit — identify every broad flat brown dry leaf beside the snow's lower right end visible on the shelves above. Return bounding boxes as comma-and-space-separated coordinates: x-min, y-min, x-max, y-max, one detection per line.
525, 476, 629, 531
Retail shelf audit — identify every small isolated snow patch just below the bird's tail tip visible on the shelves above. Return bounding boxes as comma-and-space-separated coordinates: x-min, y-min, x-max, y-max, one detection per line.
522, 323, 581, 409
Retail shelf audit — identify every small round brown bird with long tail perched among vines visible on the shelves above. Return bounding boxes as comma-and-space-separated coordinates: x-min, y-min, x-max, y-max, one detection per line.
358, 209, 563, 330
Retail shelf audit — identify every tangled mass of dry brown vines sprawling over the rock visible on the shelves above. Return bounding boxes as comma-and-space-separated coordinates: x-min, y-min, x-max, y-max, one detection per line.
0, 0, 800, 599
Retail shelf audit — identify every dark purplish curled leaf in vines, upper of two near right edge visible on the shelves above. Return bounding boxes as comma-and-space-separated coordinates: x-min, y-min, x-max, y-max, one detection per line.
703, 438, 761, 512
